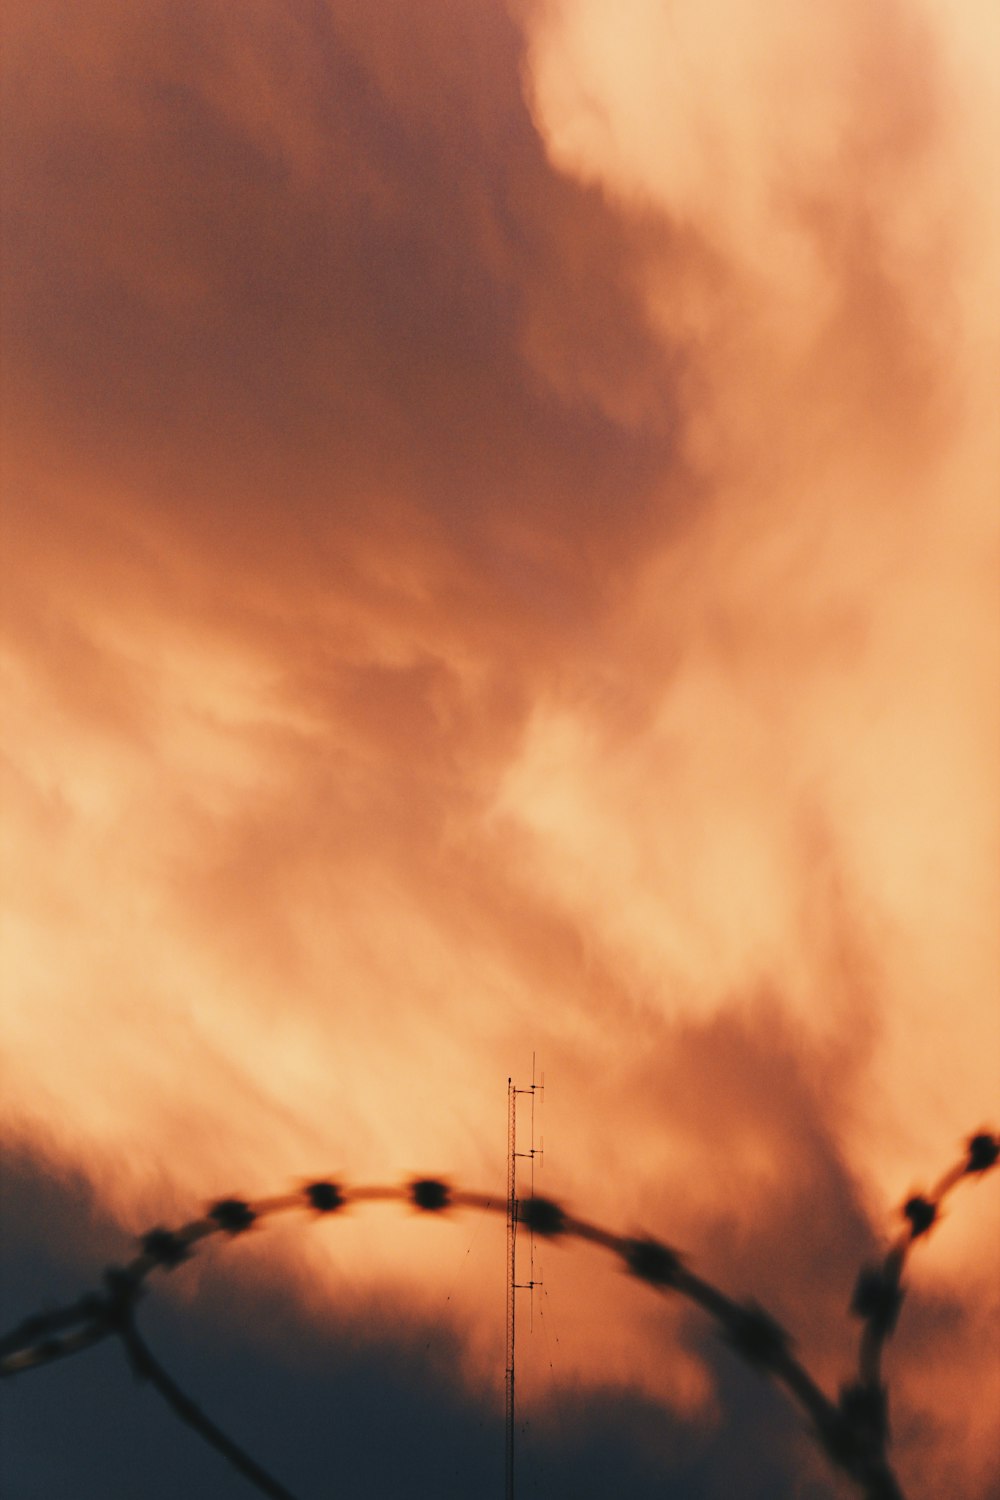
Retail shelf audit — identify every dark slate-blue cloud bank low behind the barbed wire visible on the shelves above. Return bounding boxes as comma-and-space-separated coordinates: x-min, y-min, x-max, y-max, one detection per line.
0, 1157, 828, 1500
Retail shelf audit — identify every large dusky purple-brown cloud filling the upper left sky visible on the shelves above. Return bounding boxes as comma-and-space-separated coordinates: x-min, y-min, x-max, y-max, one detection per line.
6, 6, 683, 638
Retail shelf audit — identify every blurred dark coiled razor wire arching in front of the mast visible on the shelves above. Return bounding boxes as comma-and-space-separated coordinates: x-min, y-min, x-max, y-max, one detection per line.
0, 1131, 1000, 1500
